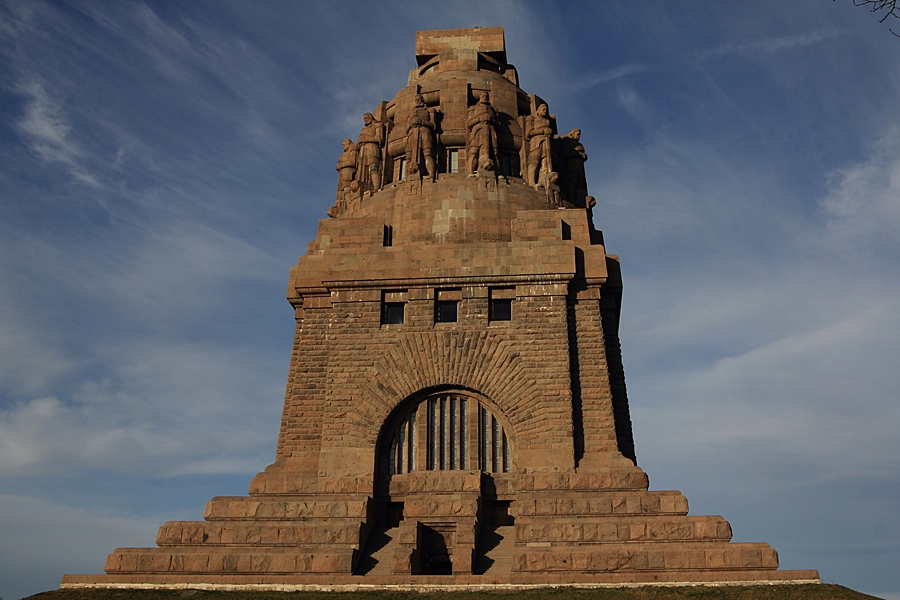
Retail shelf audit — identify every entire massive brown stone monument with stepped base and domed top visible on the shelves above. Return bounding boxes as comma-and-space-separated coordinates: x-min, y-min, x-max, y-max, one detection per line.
63, 27, 818, 589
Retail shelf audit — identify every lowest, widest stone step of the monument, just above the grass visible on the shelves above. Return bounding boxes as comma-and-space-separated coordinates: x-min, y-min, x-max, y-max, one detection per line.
60, 570, 822, 592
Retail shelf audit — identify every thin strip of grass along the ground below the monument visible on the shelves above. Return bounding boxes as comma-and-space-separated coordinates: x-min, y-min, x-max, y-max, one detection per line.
26, 584, 875, 600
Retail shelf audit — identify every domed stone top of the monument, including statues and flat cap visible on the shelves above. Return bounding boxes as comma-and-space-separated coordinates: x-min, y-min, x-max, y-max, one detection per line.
328, 27, 593, 243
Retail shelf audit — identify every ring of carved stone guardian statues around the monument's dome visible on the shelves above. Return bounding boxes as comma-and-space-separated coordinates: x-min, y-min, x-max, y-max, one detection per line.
328, 84, 593, 217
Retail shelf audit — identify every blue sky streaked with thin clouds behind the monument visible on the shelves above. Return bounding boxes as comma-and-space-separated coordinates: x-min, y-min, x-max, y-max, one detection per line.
0, 0, 900, 599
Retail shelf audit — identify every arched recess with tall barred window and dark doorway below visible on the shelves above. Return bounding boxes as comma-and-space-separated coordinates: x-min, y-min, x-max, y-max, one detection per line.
371, 388, 516, 575
